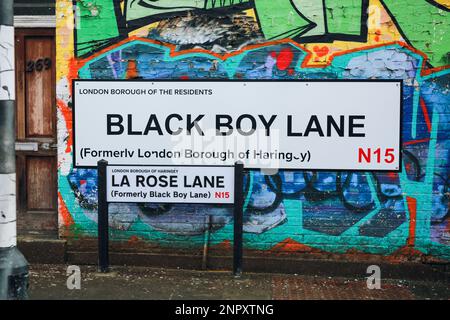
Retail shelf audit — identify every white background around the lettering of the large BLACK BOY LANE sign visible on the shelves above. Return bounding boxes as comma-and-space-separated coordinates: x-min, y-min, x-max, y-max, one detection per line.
73, 80, 402, 171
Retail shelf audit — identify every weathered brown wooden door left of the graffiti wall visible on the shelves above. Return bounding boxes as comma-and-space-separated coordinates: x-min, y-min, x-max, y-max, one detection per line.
15, 29, 58, 235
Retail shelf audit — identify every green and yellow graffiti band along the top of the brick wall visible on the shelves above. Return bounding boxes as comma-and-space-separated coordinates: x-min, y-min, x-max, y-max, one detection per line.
75, 0, 450, 66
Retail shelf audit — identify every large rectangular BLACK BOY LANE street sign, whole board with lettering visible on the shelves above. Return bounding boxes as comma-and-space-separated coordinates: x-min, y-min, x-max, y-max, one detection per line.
73, 80, 402, 171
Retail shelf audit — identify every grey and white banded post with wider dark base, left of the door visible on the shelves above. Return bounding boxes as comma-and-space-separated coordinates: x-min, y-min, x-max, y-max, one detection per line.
0, 0, 28, 300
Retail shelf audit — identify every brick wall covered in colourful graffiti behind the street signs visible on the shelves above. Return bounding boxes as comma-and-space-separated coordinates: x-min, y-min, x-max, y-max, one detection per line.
56, 0, 450, 260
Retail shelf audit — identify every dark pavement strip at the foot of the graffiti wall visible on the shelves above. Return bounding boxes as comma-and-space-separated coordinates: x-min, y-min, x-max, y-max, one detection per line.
29, 264, 450, 300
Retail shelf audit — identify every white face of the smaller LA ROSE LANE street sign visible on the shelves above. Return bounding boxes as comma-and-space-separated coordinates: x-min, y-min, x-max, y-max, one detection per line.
106, 166, 234, 204
